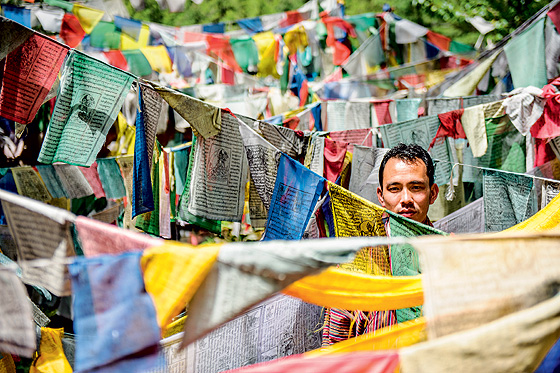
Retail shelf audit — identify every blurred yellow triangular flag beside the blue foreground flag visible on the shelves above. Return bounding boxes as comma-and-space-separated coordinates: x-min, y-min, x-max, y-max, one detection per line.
140, 242, 221, 330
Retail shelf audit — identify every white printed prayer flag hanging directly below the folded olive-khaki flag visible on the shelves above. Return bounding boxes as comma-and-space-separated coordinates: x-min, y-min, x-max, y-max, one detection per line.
186, 109, 248, 222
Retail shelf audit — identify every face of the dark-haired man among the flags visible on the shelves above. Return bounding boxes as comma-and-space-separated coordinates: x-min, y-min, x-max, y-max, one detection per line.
377, 158, 439, 223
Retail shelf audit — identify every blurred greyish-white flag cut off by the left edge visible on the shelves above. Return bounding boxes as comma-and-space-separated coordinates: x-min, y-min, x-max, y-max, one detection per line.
0, 267, 36, 357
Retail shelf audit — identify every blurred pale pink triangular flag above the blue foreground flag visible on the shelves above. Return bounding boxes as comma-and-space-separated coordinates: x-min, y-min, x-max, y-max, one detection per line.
75, 216, 163, 257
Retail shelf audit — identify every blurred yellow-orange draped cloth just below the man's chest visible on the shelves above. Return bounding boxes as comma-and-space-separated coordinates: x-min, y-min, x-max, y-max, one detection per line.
282, 267, 424, 311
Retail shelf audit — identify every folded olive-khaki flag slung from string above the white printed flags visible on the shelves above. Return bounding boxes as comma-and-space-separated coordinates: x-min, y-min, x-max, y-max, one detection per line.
152, 84, 222, 139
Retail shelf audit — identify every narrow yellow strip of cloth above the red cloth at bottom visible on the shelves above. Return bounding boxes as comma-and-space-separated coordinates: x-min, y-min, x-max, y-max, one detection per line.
304, 317, 426, 357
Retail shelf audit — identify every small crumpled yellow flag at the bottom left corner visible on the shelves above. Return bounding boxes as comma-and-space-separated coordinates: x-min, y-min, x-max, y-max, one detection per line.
29, 328, 72, 373
